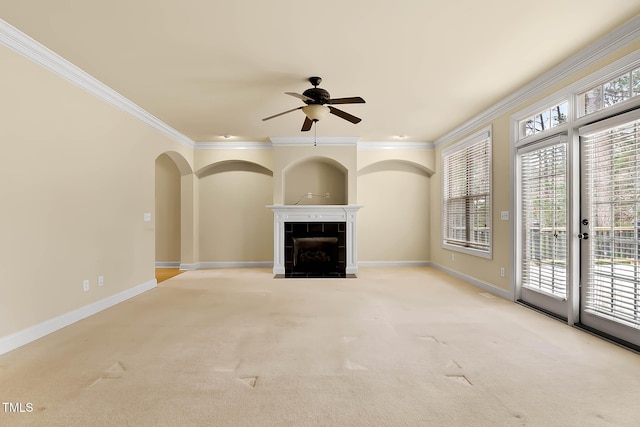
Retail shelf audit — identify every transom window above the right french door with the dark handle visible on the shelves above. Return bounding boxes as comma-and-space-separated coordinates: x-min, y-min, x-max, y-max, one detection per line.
577, 68, 640, 116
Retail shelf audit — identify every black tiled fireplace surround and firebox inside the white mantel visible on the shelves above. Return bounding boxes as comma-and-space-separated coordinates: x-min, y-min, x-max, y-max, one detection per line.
284, 222, 346, 277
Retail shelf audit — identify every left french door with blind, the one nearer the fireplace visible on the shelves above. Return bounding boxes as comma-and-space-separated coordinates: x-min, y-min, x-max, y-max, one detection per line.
516, 136, 568, 318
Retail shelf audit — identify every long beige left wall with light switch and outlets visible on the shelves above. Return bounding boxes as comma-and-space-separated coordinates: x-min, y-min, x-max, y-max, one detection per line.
0, 46, 191, 337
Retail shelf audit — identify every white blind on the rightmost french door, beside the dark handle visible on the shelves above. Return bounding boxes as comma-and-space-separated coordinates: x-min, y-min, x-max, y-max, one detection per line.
581, 120, 640, 328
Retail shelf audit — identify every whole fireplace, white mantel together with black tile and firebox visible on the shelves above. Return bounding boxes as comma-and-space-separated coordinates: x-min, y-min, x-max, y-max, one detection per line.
267, 205, 362, 277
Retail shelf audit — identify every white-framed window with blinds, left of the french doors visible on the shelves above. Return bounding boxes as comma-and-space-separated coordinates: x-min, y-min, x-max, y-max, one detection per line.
442, 129, 491, 258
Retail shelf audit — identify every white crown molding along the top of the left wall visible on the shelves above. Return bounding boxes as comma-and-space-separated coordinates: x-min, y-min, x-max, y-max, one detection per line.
0, 19, 195, 148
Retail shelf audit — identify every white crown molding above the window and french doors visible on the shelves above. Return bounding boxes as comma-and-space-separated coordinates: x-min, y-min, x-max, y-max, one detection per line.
435, 15, 640, 147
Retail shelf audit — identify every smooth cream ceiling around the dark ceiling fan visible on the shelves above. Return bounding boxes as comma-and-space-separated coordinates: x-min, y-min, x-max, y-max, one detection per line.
0, 0, 640, 142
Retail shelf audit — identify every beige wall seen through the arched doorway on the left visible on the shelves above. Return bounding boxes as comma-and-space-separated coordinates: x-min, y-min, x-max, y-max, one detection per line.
155, 154, 181, 263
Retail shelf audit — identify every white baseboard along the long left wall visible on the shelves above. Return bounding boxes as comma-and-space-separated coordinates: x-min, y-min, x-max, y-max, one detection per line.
0, 279, 158, 355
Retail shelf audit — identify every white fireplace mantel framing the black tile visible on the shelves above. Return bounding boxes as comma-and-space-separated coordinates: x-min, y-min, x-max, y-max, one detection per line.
267, 205, 362, 276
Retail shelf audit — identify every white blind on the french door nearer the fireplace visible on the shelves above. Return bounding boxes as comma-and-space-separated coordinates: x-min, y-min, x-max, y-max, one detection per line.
520, 142, 567, 299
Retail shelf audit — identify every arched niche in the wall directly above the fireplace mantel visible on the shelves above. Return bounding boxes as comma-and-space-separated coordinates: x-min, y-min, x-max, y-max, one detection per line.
282, 156, 348, 205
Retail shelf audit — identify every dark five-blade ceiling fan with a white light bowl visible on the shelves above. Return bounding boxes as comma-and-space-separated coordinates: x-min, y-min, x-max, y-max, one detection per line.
262, 77, 364, 132
